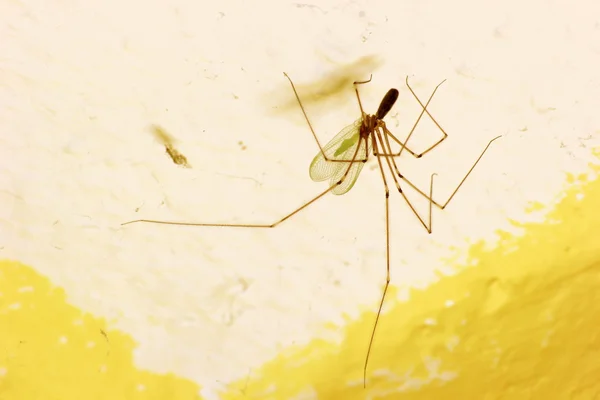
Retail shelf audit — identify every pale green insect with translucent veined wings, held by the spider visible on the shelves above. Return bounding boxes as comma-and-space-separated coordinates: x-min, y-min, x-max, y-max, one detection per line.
309, 118, 367, 195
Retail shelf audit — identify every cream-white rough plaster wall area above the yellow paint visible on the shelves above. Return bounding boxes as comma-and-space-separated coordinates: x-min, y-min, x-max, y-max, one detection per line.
0, 0, 600, 398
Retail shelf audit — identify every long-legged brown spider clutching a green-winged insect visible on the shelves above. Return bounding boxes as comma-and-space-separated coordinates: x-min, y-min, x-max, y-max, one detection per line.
122, 72, 501, 387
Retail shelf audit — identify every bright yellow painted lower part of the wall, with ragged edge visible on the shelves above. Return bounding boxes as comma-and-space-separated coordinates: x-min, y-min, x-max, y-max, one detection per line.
0, 159, 600, 400
